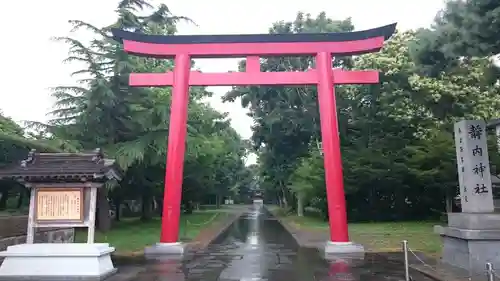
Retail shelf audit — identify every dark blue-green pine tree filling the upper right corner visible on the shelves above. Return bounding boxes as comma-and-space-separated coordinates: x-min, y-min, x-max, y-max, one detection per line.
413, 0, 500, 76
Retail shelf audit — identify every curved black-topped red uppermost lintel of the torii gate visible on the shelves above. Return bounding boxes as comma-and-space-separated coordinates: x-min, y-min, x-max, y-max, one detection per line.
112, 23, 396, 58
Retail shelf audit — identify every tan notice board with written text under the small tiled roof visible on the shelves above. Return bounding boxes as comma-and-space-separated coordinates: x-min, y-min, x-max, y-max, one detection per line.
35, 187, 85, 223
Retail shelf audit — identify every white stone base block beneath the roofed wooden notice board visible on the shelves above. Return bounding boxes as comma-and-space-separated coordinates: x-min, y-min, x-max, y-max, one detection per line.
0, 243, 116, 281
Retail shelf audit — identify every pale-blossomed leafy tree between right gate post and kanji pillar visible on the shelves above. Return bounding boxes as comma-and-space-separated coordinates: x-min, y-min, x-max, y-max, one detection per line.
340, 31, 500, 219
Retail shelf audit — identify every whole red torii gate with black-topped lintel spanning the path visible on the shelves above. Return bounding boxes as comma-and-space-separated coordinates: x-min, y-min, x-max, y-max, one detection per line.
112, 24, 396, 252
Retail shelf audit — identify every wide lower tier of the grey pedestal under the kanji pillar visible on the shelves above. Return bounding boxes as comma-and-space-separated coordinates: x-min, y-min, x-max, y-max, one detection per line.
434, 222, 500, 275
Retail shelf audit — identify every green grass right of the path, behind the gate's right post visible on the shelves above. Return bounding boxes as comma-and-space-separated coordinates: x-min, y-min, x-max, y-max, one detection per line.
285, 212, 441, 257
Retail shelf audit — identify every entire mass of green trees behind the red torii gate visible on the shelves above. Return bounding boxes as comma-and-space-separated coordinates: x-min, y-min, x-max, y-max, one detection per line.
0, 0, 500, 228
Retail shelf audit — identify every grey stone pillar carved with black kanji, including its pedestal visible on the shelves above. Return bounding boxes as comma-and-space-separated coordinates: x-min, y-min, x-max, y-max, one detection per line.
435, 120, 500, 277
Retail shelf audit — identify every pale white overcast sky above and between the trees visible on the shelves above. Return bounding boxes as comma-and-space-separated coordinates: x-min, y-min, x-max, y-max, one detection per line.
0, 0, 444, 164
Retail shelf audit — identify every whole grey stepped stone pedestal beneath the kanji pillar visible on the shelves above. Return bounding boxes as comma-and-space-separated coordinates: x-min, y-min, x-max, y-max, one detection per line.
434, 213, 500, 274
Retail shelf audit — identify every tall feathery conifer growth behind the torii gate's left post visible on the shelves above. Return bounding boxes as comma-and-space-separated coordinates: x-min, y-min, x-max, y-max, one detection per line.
27, 0, 245, 230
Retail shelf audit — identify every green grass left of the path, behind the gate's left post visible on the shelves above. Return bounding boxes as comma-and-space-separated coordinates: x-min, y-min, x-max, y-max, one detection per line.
75, 210, 228, 254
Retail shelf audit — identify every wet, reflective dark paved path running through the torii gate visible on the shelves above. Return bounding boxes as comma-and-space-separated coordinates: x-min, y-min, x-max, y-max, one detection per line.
111, 203, 429, 281
